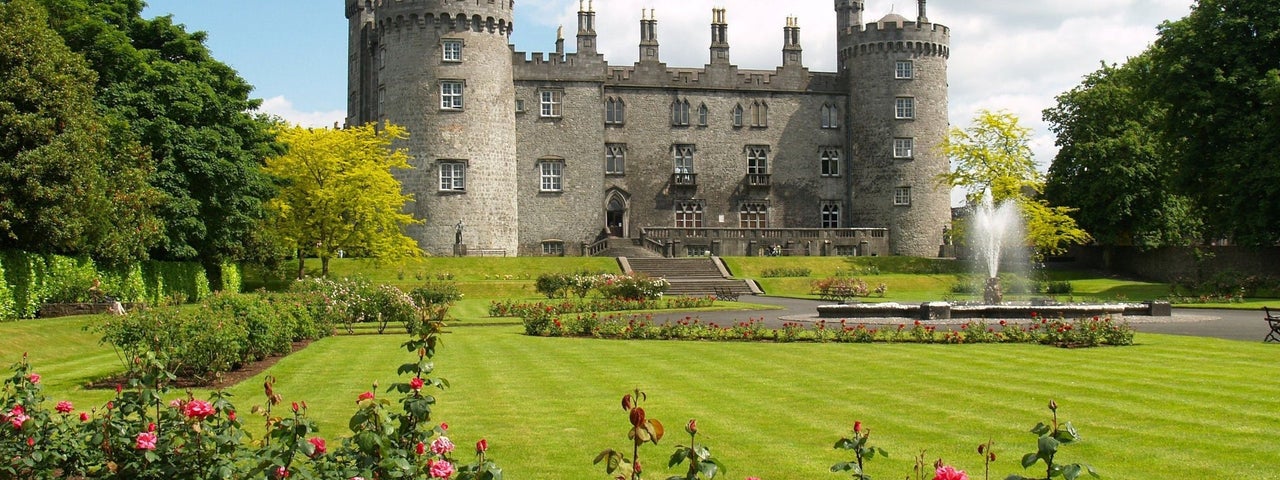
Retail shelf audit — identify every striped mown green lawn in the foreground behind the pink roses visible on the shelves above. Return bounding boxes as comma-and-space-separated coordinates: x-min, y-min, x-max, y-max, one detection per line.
0, 313, 1280, 479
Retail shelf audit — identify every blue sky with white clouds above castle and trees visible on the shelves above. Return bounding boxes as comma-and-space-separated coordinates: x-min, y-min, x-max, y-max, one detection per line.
143, 0, 1193, 169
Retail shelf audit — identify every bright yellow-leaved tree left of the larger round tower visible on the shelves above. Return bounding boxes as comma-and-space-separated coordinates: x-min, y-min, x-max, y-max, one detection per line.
266, 124, 420, 278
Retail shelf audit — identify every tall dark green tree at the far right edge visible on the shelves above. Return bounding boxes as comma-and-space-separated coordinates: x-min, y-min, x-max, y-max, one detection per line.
1152, 0, 1280, 244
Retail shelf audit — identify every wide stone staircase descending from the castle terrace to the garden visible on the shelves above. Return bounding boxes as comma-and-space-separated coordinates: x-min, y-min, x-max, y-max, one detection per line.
618, 257, 762, 297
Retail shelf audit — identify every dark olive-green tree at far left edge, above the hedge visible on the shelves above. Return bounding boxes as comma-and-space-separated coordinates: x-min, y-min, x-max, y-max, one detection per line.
0, 0, 160, 262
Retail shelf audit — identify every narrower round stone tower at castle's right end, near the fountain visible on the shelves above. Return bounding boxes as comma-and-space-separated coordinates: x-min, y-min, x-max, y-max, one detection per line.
836, 0, 951, 256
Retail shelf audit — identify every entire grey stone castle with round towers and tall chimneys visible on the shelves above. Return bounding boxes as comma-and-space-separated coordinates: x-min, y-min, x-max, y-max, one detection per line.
346, 0, 951, 256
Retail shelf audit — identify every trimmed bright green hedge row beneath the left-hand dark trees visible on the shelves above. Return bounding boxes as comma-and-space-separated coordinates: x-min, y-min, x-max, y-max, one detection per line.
0, 251, 241, 320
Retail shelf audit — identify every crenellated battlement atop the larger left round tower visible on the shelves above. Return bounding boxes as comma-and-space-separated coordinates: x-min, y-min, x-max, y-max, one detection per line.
368, 0, 515, 36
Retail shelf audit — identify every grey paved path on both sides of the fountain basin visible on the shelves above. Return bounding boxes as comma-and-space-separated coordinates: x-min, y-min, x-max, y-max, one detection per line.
654, 296, 1268, 342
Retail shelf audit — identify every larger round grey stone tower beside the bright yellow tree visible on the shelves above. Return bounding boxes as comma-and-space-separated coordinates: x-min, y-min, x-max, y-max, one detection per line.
358, 0, 518, 255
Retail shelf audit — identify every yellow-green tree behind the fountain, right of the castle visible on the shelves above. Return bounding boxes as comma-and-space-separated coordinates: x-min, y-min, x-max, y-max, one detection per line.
938, 110, 1091, 256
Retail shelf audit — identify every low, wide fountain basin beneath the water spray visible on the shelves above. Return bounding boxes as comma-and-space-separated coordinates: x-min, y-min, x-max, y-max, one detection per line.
818, 301, 1172, 320
